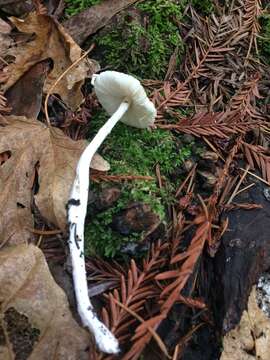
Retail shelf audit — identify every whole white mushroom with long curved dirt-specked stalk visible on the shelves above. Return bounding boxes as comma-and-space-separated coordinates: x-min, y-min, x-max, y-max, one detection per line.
68, 71, 156, 353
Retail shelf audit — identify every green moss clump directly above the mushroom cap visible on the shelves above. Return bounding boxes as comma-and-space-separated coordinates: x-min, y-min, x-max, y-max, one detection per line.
95, 0, 185, 79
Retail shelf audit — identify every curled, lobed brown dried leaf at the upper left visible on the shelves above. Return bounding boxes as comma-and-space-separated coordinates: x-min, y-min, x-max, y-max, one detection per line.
0, 12, 98, 110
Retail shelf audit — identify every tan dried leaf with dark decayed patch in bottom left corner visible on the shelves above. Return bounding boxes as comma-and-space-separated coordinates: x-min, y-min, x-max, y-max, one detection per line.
0, 245, 90, 360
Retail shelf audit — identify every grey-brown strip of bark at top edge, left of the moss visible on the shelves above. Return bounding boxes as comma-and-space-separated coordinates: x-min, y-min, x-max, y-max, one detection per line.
63, 0, 138, 45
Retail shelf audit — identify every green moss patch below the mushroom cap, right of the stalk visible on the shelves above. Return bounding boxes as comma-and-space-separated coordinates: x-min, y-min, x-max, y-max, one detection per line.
85, 110, 192, 257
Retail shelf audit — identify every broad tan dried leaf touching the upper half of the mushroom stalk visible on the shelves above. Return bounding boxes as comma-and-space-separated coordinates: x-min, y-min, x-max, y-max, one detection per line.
0, 116, 86, 235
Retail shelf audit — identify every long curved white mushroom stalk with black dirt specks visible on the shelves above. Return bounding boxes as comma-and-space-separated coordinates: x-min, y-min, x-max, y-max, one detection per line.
68, 101, 129, 354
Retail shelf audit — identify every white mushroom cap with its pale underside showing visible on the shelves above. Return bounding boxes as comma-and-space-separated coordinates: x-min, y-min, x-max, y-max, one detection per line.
92, 71, 157, 129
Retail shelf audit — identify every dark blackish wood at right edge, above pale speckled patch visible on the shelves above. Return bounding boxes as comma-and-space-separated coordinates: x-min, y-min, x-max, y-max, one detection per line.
211, 182, 270, 333
